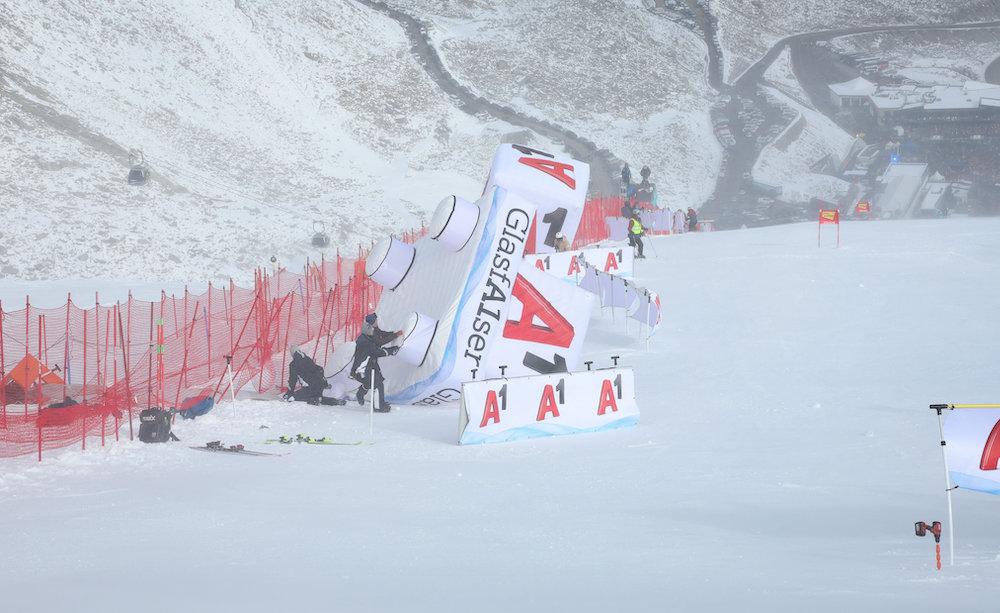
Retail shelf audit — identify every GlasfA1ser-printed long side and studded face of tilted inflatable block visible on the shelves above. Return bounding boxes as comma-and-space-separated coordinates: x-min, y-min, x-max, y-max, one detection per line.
375, 188, 535, 404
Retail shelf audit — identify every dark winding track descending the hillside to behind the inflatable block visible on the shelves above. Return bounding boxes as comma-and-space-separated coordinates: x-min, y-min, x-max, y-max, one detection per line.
356, 0, 623, 195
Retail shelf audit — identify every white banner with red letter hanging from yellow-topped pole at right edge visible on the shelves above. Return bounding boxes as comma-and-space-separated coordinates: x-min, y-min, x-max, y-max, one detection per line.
944, 409, 1000, 494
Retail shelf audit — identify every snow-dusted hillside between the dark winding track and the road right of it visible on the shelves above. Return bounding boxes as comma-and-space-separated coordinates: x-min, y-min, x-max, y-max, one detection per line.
391, 0, 722, 206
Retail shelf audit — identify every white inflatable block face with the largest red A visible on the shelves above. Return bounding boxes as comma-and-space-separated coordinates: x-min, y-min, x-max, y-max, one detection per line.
480, 266, 594, 378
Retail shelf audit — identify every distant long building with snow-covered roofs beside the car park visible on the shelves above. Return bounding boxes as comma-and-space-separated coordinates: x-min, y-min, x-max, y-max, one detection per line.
829, 77, 1000, 141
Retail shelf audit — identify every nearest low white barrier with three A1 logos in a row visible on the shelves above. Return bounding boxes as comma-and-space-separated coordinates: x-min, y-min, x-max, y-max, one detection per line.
459, 368, 639, 445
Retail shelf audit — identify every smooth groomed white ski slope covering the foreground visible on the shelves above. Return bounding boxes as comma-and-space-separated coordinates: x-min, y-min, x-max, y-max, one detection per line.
0, 218, 1000, 613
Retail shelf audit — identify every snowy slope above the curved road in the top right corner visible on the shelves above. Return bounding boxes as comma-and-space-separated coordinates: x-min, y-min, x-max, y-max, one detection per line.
707, 0, 1000, 82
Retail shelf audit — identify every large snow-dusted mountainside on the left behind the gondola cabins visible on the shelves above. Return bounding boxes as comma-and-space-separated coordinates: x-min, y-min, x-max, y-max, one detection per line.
0, 0, 552, 281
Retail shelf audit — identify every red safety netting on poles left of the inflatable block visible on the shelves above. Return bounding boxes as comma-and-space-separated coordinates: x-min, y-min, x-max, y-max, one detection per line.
0, 237, 426, 459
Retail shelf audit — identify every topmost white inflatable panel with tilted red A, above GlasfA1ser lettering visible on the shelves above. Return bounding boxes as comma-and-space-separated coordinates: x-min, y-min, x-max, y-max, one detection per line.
486, 145, 590, 253
